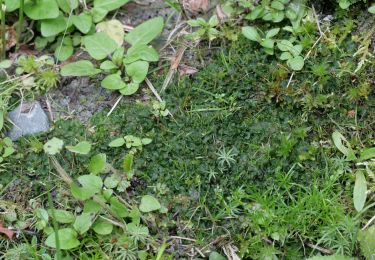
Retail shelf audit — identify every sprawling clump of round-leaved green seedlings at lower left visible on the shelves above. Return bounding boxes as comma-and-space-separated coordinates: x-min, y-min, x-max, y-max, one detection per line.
35, 138, 161, 256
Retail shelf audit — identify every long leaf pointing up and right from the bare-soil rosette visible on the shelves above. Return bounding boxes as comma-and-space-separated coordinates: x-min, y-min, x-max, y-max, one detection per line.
125, 16, 164, 45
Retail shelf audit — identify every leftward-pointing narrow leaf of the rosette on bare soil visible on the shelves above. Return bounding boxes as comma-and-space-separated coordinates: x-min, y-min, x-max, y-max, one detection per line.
60, 60, 101, 77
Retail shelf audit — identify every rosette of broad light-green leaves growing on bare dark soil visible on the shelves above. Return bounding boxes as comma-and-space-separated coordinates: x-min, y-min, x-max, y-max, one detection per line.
61, 17, 163, 95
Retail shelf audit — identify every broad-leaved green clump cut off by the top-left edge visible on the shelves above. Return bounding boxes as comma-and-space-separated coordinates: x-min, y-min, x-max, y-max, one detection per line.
5, 0, 129, 61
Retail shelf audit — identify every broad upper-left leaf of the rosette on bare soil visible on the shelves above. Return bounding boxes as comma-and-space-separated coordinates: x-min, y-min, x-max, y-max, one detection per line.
83, 32, 118, 60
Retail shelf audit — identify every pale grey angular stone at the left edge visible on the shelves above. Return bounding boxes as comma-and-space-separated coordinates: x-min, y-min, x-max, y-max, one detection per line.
7, 101, 50, 141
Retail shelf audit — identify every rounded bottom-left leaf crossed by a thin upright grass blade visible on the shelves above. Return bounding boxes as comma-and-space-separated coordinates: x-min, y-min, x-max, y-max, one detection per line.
45, 228, 80, 250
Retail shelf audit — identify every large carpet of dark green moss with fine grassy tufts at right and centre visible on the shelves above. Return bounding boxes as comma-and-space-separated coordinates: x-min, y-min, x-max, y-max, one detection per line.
2, 28, 375, 259
